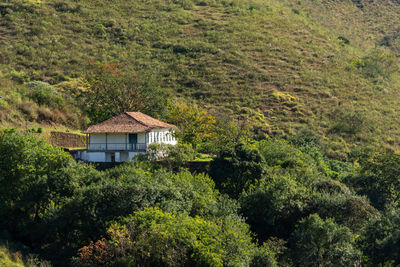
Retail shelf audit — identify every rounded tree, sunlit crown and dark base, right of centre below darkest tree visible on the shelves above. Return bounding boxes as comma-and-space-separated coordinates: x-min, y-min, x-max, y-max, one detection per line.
239, 176, 310, 241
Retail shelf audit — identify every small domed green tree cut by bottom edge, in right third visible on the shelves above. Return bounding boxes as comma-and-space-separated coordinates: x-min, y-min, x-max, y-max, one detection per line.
289, 214, 361, 266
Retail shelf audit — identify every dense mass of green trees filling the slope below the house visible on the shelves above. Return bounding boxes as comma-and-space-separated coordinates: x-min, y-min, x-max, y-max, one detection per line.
0, 130, 399, 266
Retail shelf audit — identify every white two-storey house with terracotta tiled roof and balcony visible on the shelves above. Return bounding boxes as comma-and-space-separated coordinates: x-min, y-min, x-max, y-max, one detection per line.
76, 112, 177, 162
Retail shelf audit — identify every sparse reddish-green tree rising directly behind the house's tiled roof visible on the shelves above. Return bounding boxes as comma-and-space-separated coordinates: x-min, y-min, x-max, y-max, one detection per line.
83, 62, 169, 124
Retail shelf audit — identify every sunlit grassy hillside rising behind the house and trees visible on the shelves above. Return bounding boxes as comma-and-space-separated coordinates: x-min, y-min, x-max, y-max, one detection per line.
0, 0, 400, 157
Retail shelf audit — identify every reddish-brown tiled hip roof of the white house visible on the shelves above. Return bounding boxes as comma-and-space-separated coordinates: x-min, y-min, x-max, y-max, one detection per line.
83, 112, 178, 133
